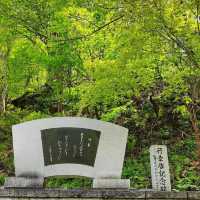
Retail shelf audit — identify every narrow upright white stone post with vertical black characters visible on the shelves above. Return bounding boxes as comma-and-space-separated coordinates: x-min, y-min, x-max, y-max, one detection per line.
150, 145, 171, 191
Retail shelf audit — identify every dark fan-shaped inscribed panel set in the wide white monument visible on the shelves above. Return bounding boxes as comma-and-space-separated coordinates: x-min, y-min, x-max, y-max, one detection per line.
41, 127, 101, 166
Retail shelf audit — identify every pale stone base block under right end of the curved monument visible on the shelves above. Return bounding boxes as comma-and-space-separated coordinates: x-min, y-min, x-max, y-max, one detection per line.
93, 179, 130, 189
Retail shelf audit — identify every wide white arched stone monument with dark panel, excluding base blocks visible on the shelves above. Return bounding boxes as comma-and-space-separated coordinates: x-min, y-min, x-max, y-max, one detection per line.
12, 117, 128, 179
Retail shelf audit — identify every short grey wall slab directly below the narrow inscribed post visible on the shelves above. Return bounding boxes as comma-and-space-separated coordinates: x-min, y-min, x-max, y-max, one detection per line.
146, 192, 187, 200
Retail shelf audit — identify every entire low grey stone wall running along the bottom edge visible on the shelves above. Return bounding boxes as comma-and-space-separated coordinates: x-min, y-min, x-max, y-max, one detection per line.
0, 188, 200, 200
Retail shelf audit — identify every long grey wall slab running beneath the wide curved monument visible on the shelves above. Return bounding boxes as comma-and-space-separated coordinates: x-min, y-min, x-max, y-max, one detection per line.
0, 188, 145, 199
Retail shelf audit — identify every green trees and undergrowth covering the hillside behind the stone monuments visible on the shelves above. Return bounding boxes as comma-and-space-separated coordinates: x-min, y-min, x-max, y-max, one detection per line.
0, 0, 200, 190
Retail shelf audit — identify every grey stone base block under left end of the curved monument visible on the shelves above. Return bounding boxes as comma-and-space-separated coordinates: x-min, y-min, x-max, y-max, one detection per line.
4, 177, 44, 188
